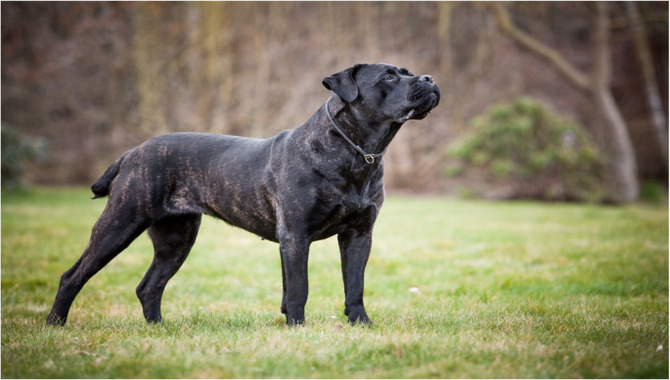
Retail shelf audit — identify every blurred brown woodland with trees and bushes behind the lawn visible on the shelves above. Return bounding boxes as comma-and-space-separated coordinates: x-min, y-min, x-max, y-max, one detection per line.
1, 2, 668, 202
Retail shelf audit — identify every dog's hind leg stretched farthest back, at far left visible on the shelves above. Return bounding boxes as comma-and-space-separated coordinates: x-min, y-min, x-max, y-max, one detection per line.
47, 200, 151, 325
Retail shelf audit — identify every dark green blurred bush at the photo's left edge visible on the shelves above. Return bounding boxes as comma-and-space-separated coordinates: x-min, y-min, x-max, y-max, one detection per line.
1, 123, 44, 189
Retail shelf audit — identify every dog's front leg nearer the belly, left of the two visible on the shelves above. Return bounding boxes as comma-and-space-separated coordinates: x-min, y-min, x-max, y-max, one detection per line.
279, 236, 309, 326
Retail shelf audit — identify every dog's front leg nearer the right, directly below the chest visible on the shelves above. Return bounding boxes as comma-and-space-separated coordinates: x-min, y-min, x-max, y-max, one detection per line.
337, 230, 372, 325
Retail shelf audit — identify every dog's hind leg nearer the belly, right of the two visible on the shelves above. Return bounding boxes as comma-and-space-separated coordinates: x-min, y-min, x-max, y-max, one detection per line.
137, 214, 202, 322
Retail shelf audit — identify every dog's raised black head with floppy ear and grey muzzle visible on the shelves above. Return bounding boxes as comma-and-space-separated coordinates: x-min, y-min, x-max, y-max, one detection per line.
322, 63, 440, 123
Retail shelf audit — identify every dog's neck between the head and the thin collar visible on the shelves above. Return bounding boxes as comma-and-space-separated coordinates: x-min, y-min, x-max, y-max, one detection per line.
324, 94, 402, 163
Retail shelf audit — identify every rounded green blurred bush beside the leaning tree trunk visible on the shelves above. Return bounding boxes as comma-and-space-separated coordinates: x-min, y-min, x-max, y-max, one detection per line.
449, 97, 605, 201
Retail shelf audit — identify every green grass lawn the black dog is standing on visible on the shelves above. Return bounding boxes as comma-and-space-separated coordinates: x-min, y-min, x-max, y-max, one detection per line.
2, 189, 668, 378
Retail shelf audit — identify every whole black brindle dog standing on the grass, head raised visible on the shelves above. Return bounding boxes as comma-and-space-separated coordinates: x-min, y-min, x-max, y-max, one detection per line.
47, 64, 440, 325
